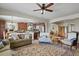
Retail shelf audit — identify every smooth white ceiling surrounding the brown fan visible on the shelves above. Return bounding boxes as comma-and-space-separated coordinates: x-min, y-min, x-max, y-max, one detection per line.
0, 3, 79, 20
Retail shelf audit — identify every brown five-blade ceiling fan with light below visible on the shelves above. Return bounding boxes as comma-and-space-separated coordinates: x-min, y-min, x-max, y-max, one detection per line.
34, 3, 54, 14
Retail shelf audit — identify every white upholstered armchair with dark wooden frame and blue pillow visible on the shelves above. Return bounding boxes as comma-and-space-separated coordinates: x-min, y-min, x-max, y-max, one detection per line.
60, 32, 78, 49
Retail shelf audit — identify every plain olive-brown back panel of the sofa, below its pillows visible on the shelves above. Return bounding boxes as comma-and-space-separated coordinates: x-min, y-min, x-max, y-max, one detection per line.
10, 39, 32, 49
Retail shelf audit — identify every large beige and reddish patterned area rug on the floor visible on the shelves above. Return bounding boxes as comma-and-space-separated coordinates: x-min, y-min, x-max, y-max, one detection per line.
12, 43, 77, 56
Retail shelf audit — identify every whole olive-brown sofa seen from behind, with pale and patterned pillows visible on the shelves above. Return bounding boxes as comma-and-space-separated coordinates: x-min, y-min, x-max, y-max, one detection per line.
9, 33, 32, 49
